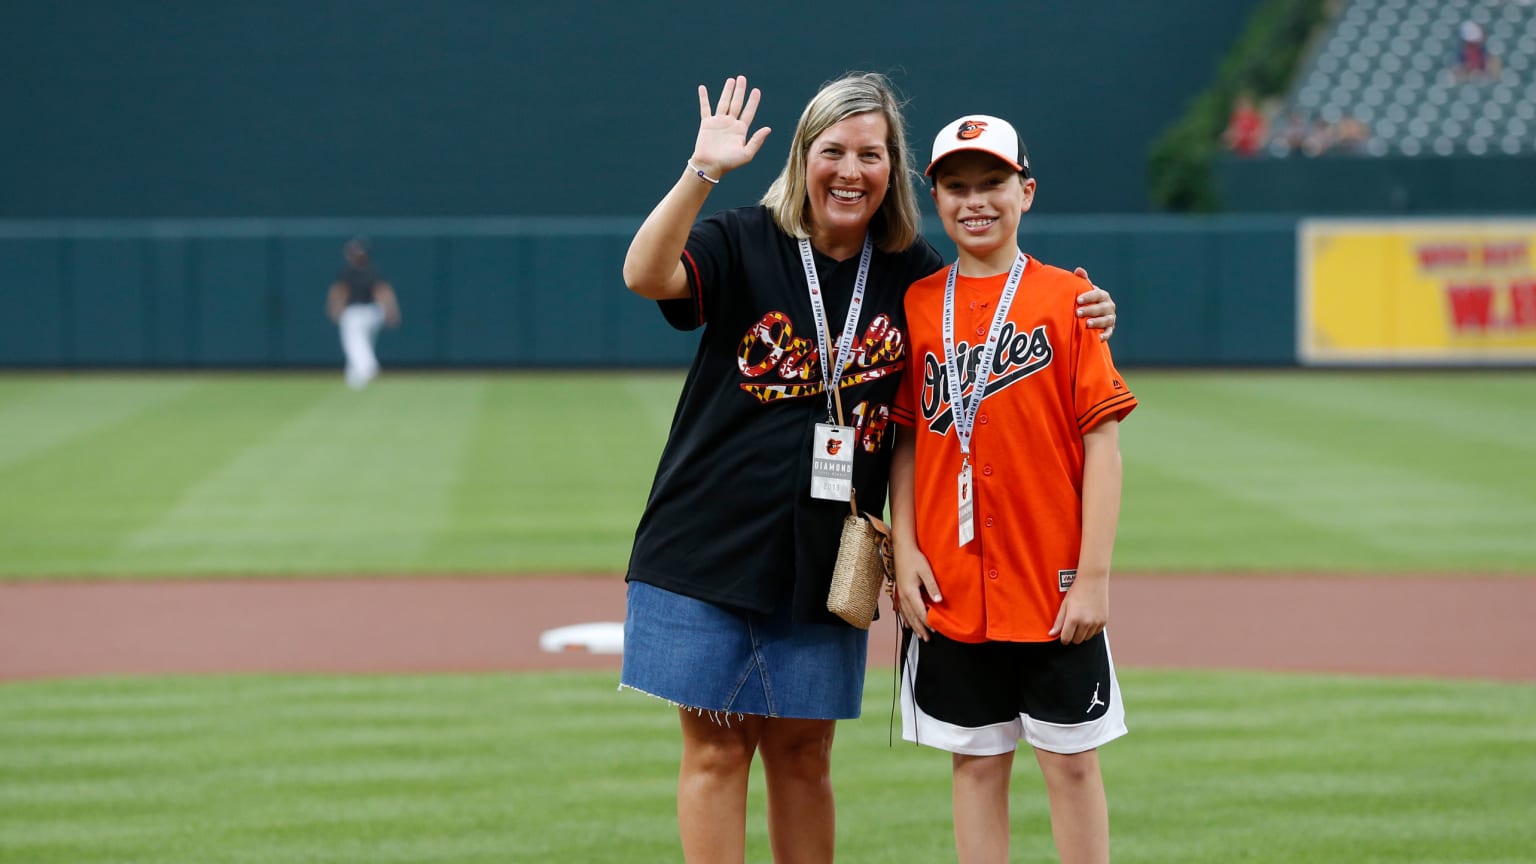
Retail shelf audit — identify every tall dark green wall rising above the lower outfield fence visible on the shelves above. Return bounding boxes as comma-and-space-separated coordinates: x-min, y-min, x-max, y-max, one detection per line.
0, 0, 1256, 218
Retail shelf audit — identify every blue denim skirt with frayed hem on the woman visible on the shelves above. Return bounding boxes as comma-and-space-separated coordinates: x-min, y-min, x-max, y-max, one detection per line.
619, 581, 869, 719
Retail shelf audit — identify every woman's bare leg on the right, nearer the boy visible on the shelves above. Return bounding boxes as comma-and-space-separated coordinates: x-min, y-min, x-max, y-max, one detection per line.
759, 718, 837, 864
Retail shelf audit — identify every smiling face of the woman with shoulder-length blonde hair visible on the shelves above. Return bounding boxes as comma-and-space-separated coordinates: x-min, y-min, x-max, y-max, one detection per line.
805, 111, 891, 252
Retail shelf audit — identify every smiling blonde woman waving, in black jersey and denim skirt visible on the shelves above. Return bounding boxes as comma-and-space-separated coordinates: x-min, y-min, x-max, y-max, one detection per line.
622, 75, 940, 861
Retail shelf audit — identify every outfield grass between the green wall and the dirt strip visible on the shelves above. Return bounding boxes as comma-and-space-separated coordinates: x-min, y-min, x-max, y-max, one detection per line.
0, 371, 1536, 578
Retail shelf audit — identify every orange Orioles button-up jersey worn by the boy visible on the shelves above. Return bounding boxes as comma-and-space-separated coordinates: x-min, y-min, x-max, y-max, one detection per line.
891, 258, 1137, 643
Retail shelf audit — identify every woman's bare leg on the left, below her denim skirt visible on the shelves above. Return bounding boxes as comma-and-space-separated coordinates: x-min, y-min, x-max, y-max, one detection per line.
677, 709, 765, 864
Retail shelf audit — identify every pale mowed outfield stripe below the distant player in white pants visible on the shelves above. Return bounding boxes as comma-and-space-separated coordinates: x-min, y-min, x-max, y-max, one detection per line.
118, 377, 484, 573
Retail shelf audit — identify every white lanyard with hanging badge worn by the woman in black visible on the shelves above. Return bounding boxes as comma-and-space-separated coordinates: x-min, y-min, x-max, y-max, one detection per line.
800, 234, 874, 501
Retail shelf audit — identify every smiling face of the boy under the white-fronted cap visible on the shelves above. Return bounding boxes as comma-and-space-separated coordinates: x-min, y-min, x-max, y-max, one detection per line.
932, 151, 1035, 275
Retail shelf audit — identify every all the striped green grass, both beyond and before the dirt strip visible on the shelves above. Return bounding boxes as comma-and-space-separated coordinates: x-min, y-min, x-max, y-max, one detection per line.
0, 371, 1536, 864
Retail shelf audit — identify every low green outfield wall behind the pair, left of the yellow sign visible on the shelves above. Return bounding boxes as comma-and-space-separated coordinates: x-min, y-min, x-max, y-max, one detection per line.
0, 215, 1296, 369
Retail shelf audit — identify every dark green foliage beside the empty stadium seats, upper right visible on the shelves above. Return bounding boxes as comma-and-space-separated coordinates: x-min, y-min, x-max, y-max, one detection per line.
1147, 0, 1329, 212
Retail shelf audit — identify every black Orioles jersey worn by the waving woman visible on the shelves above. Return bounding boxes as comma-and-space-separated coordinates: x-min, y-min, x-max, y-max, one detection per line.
627, 206, 942, 623
